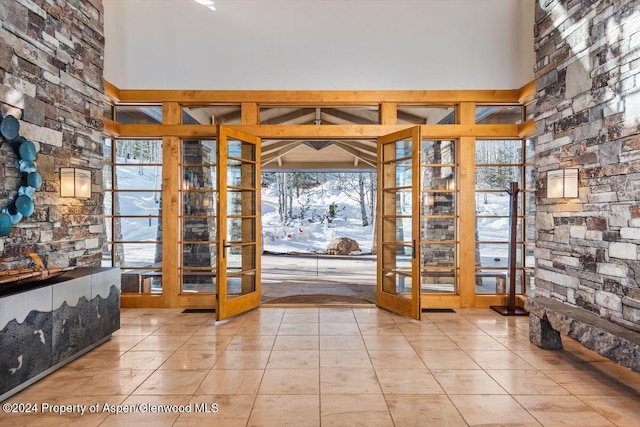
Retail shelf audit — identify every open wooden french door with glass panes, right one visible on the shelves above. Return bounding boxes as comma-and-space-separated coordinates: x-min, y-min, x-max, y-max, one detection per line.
377, 127, 421, 319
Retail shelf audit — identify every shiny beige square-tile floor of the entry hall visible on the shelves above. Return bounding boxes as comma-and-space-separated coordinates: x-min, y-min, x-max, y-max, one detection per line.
0, 307, 640, 427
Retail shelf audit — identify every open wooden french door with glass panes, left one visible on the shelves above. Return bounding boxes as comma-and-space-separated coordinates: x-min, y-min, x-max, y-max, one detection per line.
216, 126, 261, 320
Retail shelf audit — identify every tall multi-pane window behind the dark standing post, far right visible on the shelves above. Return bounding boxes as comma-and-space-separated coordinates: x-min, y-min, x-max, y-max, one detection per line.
475, 139, 535, 294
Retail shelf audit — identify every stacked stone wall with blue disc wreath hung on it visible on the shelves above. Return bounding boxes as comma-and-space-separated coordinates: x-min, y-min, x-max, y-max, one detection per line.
0, 0, 104, 268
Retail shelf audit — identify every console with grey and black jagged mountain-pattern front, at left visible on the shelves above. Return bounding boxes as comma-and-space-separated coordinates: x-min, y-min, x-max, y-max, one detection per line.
0, 267, 120, 401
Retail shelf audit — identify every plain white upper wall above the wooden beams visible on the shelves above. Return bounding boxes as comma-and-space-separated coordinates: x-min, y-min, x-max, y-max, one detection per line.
103, 0, 534, 90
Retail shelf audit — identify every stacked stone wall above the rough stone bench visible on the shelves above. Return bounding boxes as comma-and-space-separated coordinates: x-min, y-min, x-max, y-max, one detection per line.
535, 0, 640, 331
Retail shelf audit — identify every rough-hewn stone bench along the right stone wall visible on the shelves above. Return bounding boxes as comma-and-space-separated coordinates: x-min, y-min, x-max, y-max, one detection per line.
524, 297, 640, 372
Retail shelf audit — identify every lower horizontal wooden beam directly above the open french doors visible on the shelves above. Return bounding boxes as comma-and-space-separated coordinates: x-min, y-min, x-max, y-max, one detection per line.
107, 124, 519, 139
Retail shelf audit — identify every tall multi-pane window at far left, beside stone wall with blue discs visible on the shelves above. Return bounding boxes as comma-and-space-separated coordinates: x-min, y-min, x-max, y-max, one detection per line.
103, 138, 162, 293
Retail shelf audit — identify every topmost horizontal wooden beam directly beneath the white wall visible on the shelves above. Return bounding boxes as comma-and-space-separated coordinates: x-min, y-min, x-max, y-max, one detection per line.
118, 89, 520, 106
